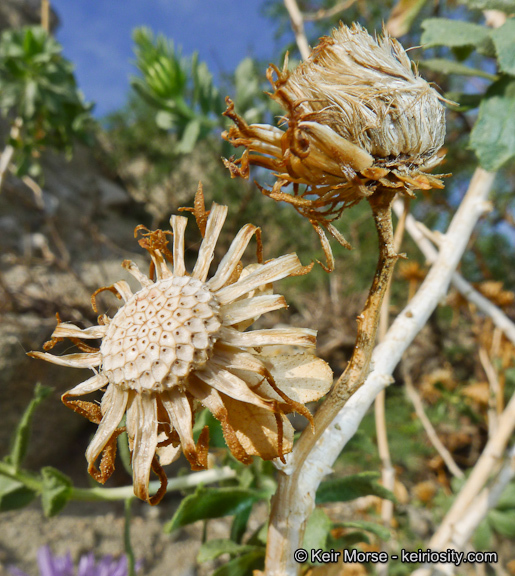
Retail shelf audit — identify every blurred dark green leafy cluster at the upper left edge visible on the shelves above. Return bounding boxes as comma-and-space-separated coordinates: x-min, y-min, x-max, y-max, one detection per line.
0, 27, 92, 175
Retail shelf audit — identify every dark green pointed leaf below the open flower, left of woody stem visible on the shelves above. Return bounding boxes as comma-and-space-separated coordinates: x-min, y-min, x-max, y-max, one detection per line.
165, 487, 263, 532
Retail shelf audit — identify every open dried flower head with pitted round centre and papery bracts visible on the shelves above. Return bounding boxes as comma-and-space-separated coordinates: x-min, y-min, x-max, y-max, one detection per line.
31, 187, 332, 504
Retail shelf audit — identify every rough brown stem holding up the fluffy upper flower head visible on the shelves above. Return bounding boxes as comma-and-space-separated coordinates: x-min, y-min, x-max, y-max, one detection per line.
265, 189, 398, 576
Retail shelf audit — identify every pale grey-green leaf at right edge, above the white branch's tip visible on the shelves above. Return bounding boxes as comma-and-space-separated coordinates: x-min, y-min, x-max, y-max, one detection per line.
470, 77, 515, 171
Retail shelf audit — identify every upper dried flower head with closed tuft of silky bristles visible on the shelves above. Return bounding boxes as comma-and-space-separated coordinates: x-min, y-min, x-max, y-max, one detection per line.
224, 24, 445, 268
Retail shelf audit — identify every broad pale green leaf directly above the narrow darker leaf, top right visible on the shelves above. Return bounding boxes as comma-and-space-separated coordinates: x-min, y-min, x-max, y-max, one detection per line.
421, 18, 489, 48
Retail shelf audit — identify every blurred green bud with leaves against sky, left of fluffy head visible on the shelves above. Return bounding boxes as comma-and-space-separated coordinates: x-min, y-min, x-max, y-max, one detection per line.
131, 28, 224, 154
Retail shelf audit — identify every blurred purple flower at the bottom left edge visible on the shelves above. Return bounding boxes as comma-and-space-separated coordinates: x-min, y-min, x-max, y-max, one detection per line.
9, 546, 141, 576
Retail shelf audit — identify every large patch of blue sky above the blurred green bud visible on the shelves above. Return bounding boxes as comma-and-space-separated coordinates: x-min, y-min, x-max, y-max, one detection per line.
51, 0, 278, 116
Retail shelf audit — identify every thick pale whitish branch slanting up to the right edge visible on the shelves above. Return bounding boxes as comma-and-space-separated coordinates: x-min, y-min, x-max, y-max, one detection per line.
268, 168, 495, 576
